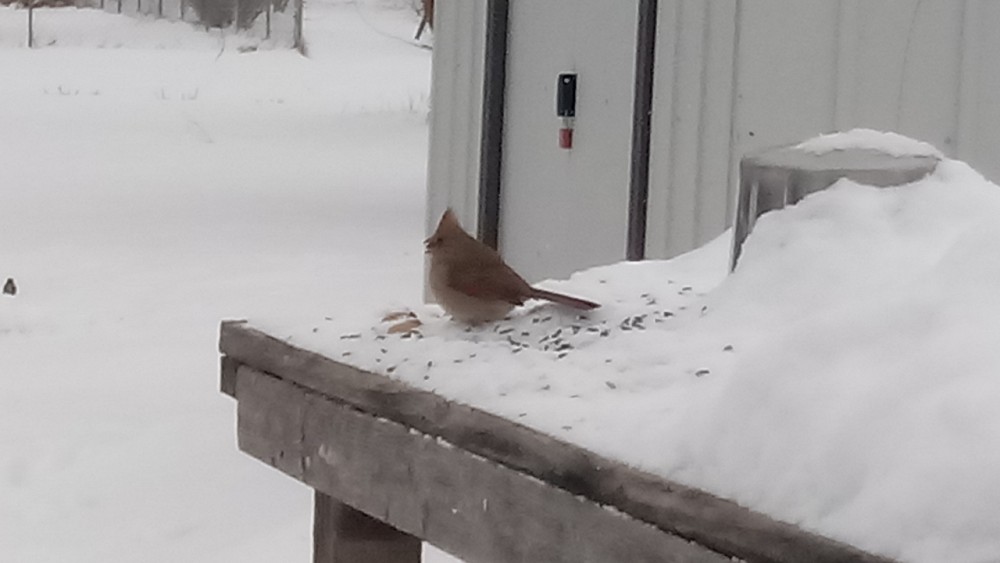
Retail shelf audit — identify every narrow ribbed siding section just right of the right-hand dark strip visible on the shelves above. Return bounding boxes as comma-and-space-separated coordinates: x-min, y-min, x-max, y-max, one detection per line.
646, 0, 737, 257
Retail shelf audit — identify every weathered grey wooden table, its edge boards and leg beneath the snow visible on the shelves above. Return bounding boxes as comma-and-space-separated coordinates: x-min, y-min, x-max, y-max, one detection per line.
220, 322, 889, 563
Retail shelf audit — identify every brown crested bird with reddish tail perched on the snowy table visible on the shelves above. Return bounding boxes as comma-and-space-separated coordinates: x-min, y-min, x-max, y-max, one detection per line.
424, 208, 600, 324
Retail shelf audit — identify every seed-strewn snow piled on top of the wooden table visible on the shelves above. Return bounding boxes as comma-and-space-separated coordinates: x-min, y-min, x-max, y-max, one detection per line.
251, 156, 1000, 561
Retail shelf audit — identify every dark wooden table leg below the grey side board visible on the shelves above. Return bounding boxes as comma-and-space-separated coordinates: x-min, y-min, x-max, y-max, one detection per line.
313, 491, 420, 563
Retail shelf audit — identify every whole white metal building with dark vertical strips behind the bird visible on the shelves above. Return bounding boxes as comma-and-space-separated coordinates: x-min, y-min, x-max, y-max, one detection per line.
427, 0, 1000, 281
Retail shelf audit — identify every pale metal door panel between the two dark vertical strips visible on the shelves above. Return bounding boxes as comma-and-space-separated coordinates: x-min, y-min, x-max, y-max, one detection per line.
500, 0, 638, 281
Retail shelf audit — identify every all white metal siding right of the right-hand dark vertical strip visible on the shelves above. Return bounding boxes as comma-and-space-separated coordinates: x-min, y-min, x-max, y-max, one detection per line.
647, 0, 1000, 257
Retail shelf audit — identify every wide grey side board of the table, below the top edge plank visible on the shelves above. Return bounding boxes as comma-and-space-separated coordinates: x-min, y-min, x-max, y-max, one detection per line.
236, 367, 729, 563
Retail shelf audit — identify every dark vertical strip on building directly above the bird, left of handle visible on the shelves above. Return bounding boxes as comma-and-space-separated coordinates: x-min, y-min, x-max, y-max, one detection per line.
477, 0, 510, 248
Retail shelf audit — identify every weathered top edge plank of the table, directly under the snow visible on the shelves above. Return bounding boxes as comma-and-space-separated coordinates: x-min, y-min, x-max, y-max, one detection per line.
220, 322, 891, 563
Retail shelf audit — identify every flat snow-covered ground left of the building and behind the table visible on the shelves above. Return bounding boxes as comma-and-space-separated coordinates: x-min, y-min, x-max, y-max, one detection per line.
0, 4, 458, 563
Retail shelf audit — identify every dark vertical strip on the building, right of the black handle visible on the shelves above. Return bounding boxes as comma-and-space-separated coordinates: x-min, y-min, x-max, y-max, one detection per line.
625, 0, 657, 260
